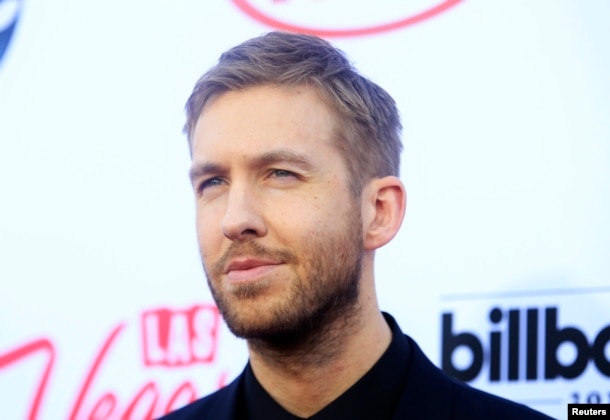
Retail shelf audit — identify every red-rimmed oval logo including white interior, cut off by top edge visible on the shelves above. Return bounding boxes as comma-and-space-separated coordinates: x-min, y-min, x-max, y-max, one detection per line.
232, 0, 462, 37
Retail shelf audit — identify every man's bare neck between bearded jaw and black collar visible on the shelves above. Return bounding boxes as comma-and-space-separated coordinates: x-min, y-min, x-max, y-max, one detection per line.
243, 304, 391, 417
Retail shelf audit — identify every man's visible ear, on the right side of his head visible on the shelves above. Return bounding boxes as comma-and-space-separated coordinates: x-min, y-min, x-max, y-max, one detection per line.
362, 176, 407, 251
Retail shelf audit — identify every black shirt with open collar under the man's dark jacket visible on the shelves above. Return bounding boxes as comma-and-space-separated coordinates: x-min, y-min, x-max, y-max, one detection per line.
240, 314, 410, 420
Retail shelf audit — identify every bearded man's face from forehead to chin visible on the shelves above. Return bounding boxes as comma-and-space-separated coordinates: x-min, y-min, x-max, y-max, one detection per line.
191, 86, 363, 340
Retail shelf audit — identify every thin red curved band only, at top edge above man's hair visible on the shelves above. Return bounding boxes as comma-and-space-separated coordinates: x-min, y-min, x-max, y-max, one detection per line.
233, 0, 462, 37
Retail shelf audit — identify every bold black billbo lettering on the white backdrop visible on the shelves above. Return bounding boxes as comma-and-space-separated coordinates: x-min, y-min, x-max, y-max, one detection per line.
441, 306, 610, 382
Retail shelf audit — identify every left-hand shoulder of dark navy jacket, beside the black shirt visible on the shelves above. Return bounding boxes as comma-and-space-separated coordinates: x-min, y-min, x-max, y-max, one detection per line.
159, 373, 243, 420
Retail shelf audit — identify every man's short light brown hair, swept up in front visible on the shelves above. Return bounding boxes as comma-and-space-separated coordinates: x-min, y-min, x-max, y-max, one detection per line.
184, 32, 402, 196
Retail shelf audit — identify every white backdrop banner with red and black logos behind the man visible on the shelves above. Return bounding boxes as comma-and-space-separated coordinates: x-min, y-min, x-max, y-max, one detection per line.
0, 0, 610, 419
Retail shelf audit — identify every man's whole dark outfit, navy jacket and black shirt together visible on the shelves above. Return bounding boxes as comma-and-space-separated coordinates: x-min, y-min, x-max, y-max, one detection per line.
158, 315, 550, 420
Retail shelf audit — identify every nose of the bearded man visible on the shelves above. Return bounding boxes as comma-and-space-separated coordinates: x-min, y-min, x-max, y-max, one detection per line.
222, 187, 267, 241
